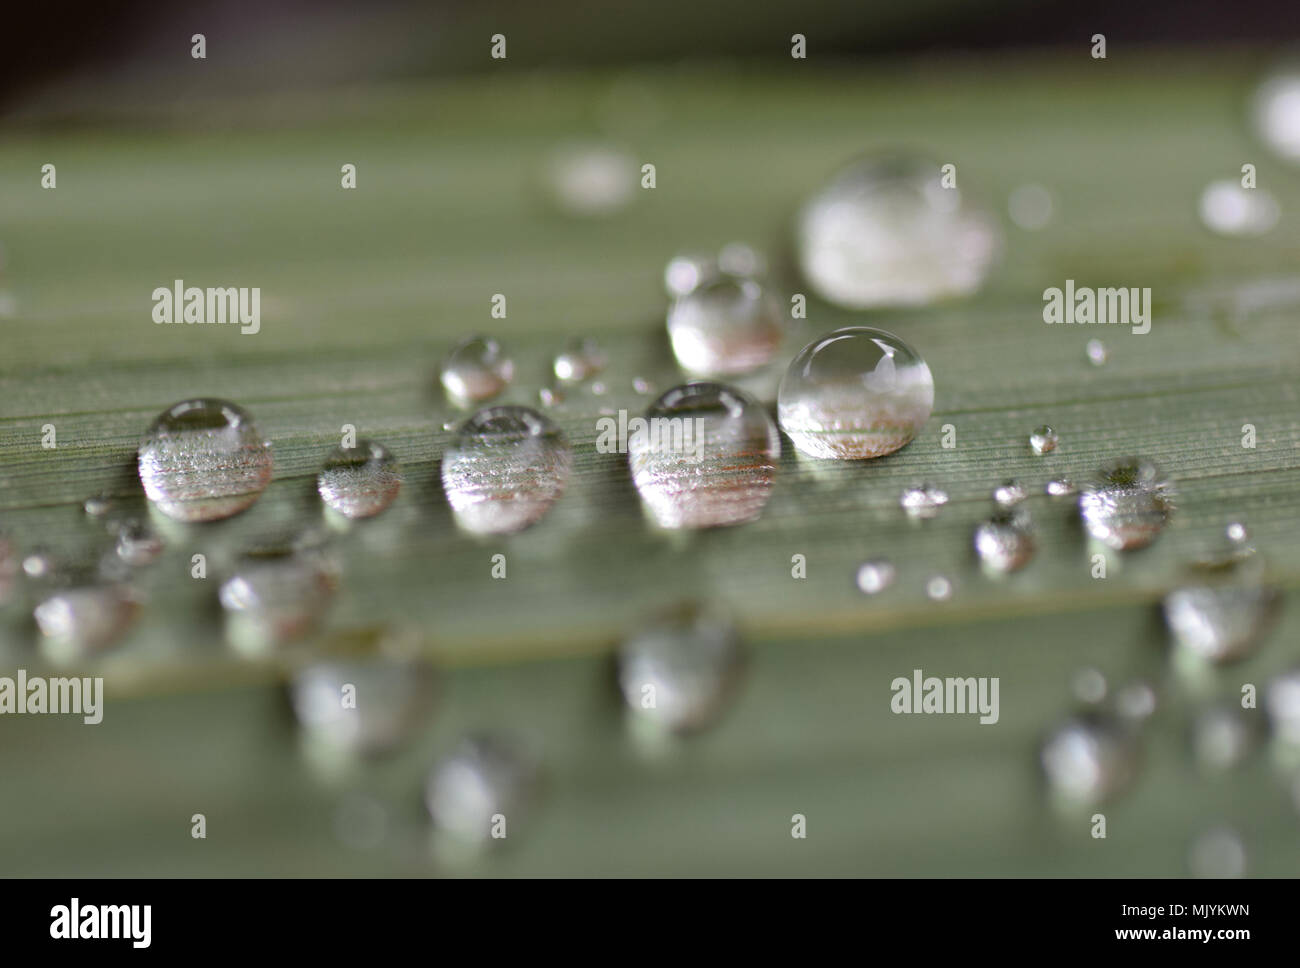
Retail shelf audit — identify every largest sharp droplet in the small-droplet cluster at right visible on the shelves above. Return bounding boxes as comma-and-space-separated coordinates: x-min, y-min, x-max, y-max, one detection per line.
1079, 457, 1174, 551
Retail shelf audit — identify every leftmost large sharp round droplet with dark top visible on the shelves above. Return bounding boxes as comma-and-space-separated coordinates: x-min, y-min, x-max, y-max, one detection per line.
139, 398, 272, 521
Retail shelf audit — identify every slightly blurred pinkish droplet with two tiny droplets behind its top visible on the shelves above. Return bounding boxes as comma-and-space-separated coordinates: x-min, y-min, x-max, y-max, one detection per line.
668, 272, 784, 376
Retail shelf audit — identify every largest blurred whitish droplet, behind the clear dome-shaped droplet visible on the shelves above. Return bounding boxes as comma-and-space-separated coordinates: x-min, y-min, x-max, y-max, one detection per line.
796, 156, 998, 309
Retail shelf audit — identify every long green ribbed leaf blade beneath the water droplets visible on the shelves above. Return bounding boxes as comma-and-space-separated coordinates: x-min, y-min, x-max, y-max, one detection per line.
0, 55, 1300, 874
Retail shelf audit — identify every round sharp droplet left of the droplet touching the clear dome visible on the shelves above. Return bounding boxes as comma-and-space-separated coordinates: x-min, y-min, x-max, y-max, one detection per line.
442, 407, 572, 534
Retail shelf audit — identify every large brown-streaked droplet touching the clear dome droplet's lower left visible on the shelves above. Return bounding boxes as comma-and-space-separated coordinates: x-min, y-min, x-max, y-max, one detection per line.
628, 383, 781, 528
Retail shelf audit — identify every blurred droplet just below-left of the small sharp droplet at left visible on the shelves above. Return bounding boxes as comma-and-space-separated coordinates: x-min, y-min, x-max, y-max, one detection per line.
218, 534, 339, 654
